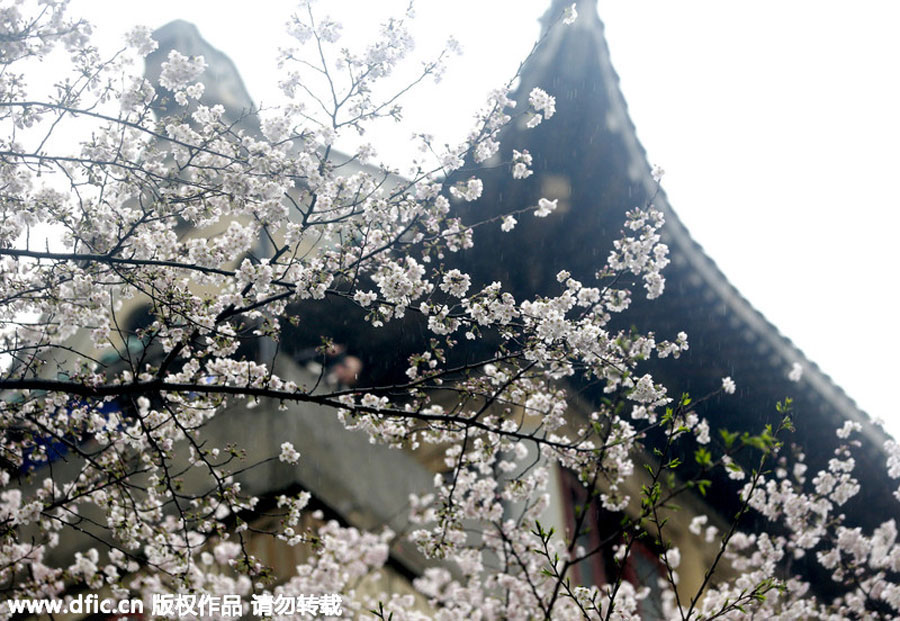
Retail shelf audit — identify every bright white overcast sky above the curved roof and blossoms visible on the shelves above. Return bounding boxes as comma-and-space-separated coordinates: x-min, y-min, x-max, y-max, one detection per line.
72, 0, 900, 435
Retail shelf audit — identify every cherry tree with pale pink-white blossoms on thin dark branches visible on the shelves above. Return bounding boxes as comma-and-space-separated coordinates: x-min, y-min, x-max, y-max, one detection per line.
0, 0, 900, 619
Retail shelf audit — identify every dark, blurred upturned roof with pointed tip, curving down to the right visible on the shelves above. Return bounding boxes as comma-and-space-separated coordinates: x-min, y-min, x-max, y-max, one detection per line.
454, 0, 898, 527
